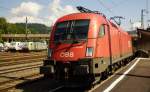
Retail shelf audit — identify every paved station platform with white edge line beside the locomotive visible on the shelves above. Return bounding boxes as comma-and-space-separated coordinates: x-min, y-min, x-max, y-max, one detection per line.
89, 58, 150, 92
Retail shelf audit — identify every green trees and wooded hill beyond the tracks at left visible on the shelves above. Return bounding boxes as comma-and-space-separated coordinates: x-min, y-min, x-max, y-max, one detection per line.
0, 17, 50, 34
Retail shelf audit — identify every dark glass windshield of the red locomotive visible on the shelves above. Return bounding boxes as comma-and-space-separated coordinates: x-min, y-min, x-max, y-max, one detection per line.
54, 20, 89, 42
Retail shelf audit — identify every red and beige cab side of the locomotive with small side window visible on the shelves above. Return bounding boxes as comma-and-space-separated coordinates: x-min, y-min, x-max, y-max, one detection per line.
96, 24, 109, 72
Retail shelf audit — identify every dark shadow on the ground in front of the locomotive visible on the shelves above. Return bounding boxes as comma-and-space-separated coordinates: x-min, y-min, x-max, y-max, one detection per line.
13, 78, 86, 92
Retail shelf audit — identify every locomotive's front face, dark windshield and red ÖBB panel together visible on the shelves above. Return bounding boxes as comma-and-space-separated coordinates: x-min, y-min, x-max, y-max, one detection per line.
50, 18, 90, 62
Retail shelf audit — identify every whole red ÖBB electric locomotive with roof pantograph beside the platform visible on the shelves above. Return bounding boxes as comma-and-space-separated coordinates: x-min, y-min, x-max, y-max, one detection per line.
40, 7, 133, 83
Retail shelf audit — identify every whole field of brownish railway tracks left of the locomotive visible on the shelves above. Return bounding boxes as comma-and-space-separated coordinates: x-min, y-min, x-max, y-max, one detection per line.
0, 53, 46, 92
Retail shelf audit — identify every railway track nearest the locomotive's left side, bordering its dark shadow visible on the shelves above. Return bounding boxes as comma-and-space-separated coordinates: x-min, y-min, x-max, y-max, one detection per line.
0, 62, 43, 92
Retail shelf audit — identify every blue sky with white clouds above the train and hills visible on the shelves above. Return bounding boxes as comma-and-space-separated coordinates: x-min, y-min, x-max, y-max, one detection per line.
0, 0, 150, 30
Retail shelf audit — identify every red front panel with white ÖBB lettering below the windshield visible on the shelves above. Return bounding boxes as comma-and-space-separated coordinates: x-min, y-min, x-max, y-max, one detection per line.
52, 42, 86, 62
